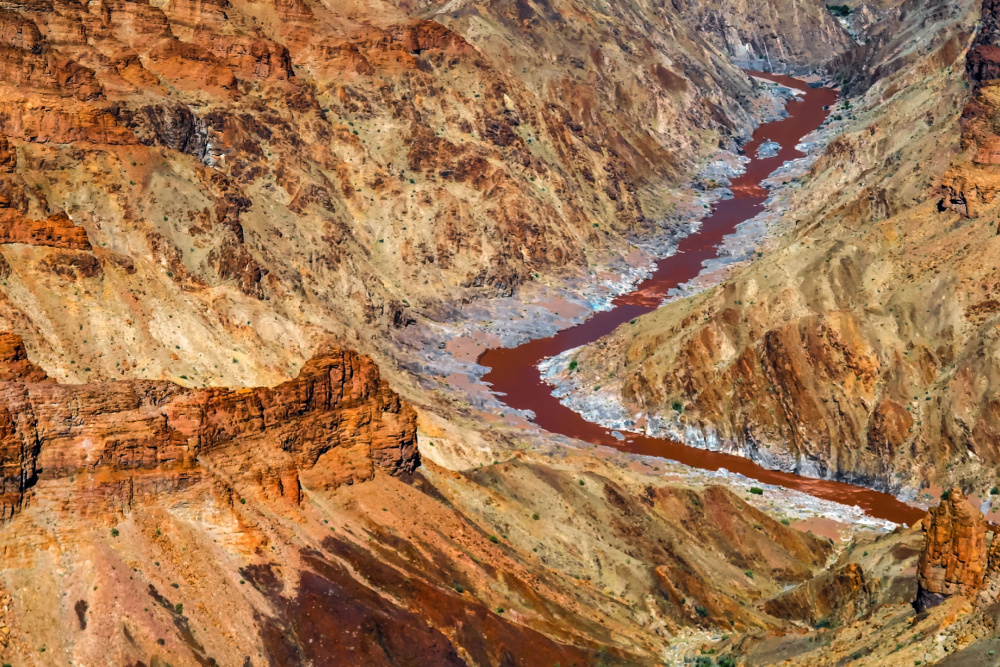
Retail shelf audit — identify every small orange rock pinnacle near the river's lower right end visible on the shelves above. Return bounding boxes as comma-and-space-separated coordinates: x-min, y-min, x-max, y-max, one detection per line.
914, 488, 987, 611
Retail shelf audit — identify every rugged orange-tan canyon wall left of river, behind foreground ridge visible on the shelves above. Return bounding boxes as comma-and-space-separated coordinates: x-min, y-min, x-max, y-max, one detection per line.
0, 0, 780, 392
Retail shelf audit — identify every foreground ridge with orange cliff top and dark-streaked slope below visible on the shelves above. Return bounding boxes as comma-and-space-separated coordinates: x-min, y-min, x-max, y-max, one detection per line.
0, 336, 860, 666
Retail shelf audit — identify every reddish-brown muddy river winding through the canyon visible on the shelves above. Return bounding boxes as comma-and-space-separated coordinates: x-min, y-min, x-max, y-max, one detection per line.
479, 73, 925, 524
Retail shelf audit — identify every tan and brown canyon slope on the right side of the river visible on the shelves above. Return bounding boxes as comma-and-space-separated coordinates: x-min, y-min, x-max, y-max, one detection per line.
577, 2, 998, 498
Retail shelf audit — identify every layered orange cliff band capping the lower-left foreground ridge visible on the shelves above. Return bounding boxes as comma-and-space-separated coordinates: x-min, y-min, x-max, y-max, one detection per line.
0, 335, 419, 519
